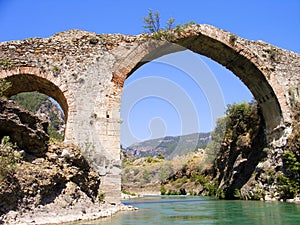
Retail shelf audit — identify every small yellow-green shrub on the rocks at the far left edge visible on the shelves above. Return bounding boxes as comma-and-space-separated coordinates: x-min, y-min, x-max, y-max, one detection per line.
0, 136, 21, 182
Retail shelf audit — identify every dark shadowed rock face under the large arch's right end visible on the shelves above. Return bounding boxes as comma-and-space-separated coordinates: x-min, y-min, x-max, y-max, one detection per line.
214, 103, 267, 199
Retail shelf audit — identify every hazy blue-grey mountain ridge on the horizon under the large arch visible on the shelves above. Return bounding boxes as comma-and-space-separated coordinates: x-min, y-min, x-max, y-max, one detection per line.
125, 133, 210, 159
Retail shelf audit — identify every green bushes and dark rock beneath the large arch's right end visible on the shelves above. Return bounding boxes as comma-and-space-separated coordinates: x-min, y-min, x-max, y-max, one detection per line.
191, 102, 268, 199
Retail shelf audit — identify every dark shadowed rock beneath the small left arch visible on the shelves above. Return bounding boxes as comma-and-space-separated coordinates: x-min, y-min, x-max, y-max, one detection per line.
0, 99, 49, 155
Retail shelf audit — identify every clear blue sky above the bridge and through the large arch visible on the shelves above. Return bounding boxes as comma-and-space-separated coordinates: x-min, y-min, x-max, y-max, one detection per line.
0, 0, 300, 146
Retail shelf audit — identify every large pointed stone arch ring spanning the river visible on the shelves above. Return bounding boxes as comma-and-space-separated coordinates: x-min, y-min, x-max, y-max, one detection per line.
114, 26, 291, 141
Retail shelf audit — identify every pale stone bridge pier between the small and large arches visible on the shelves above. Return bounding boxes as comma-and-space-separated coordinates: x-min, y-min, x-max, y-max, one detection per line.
61, 53, 121, 204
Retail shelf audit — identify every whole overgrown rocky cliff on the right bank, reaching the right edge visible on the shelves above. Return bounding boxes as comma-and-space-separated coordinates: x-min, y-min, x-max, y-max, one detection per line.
165, 102, 300, 201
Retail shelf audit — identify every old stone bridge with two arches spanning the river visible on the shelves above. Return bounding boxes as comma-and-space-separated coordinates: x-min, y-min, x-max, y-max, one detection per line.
0, 25, 300, 202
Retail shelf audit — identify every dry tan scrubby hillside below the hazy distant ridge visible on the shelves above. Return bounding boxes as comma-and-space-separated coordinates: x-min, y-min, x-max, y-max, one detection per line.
122, 150, 206, 195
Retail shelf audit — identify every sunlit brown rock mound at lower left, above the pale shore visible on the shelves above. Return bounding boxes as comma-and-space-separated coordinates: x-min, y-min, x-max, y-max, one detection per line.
0, 143, 101, 223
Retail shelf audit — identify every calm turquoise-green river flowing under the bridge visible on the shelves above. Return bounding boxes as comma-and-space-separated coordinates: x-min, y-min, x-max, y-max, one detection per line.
72, 196, 300, 225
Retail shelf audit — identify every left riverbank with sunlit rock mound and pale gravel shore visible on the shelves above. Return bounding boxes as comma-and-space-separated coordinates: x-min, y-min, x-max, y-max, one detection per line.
0, 143, 135, 224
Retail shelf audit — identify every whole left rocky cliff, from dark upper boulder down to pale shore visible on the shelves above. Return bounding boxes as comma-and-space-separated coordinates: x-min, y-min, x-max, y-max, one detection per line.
0, 99, 134, 224
